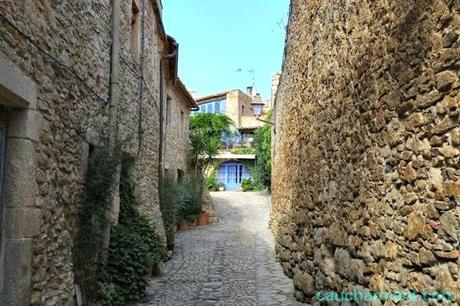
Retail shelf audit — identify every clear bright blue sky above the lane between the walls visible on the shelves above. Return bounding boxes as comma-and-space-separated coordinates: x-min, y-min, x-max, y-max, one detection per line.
162, 0, 289, 100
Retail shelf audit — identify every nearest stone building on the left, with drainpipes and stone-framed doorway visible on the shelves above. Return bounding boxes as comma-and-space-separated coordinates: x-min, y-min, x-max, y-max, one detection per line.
0, 0, 191, 306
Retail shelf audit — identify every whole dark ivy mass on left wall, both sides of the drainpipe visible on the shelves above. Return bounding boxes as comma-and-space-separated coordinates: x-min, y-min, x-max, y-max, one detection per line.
74, 147, 166, 306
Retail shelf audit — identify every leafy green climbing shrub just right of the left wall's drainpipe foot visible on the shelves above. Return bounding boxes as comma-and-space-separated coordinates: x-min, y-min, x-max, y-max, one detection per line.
98, 161, 166, 306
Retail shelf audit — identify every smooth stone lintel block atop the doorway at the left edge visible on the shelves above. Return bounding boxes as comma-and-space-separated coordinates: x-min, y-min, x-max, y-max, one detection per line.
0, 53, 37, 109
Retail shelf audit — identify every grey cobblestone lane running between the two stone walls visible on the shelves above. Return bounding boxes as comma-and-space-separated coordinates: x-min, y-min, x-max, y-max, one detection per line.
137, 192, 301, 306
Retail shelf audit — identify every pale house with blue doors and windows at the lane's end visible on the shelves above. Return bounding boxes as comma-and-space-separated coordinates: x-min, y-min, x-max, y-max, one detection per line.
196, 87, 269, 190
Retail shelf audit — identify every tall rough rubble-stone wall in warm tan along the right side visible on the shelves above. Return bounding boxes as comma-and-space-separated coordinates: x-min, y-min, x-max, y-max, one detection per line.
271, 0, 460, 305
